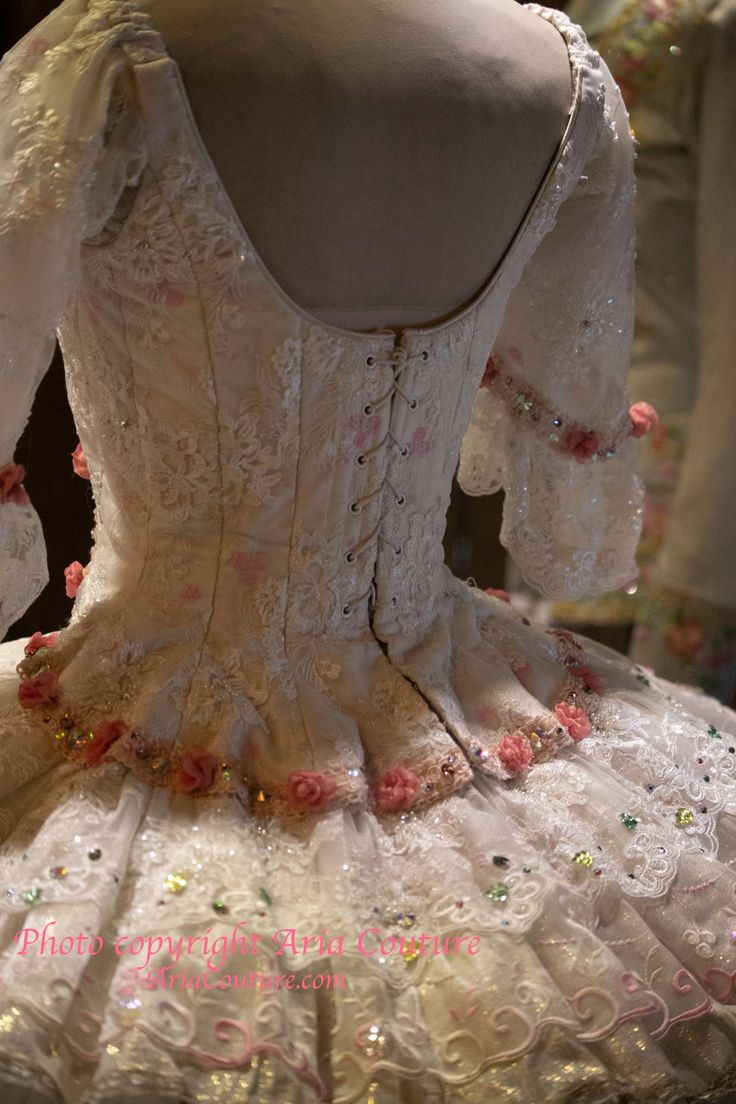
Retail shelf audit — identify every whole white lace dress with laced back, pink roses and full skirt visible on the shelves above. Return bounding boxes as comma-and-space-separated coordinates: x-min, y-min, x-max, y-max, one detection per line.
0, 0, 736, 1104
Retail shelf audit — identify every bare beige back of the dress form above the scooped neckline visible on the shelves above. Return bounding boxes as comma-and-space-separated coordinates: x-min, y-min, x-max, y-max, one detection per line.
143, 0, 572, 330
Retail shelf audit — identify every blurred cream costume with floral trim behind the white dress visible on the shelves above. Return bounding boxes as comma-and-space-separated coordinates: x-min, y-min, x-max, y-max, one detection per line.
540, 0, 736, 702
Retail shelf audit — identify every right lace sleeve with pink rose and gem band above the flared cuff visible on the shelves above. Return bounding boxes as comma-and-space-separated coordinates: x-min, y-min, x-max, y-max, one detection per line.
458, 62, 654, 598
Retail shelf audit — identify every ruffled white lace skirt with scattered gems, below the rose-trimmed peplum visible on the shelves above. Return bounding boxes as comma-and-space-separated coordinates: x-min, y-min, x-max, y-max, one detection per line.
0, 641, 736, 1104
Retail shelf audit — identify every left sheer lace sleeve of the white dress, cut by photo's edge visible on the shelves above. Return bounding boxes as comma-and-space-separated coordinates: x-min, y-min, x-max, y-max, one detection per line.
0, 0, 143, 639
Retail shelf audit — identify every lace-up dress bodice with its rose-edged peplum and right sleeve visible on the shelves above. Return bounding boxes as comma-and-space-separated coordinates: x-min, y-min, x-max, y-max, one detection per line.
0, 0, 638, 811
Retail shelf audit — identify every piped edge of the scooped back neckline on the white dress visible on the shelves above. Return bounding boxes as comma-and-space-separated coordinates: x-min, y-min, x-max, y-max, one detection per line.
158, 3, 584, 344
